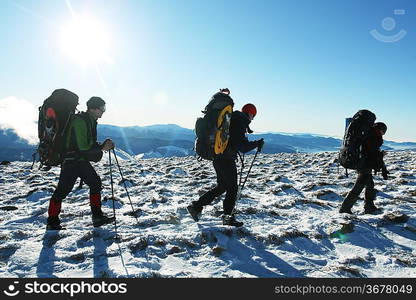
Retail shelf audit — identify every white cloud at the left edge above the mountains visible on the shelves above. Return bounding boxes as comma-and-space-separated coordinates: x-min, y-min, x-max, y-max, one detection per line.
0, 97, 38, 144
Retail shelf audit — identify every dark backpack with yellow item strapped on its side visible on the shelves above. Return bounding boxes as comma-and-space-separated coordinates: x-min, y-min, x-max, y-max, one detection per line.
194, 92, 234, 160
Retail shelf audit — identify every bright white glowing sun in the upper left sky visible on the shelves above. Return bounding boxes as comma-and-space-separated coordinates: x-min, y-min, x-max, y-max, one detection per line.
60, 15, 111, 66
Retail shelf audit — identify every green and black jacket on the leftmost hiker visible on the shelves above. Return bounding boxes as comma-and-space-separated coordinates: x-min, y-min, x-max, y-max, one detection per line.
65, 112, 103, 161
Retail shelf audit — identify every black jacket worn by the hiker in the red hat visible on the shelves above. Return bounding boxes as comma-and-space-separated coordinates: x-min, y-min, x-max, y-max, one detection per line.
218, 111, 258, 159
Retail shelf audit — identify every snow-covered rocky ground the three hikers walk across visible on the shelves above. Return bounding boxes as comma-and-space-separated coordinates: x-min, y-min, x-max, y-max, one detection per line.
0, 151, 416, 278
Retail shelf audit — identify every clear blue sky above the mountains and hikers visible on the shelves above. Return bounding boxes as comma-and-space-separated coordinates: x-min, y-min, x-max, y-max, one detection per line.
0, 0, 416, 141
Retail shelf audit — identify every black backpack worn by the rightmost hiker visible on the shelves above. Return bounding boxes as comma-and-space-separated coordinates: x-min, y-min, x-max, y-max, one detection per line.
338, 109, 376, 170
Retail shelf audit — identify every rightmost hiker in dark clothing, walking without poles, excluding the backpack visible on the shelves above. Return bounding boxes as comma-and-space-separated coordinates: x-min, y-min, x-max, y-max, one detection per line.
339, 122, 389, 214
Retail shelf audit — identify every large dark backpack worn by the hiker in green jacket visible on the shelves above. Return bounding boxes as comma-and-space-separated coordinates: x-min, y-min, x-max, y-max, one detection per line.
37, 89, 78, 167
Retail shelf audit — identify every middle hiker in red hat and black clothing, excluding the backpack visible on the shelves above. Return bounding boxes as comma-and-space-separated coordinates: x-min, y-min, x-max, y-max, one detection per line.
187, 102, 264, 227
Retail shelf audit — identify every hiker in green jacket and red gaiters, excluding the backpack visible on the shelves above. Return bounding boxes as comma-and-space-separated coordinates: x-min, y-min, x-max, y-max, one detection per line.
46, 97, 114, 230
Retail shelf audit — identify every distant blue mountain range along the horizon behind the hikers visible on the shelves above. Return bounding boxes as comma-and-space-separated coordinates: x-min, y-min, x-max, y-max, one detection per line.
0, 124, 416, 161
